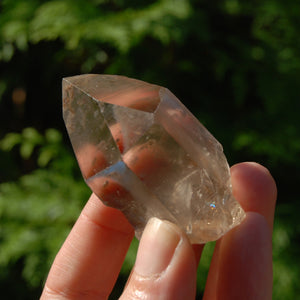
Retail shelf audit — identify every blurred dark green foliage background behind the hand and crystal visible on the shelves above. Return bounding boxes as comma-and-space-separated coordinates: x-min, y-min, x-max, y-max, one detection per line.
0, 0, 300, 299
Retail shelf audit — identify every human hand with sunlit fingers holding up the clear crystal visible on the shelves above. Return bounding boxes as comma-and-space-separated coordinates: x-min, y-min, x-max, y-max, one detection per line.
41, 163, 276, 300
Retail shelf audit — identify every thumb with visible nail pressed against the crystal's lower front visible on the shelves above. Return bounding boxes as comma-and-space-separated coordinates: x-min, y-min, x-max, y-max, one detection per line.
120, 218, 197, 300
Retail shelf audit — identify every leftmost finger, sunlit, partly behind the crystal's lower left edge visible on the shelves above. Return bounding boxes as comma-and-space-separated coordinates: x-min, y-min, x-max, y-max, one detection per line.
41, 194, 134, 299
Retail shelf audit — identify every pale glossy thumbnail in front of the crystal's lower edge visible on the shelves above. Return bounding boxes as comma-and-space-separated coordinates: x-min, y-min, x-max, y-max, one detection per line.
135, 218, 180, 277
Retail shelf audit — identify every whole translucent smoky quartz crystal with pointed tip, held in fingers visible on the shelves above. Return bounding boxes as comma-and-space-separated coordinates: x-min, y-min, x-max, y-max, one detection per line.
63, 74, 245, 243
